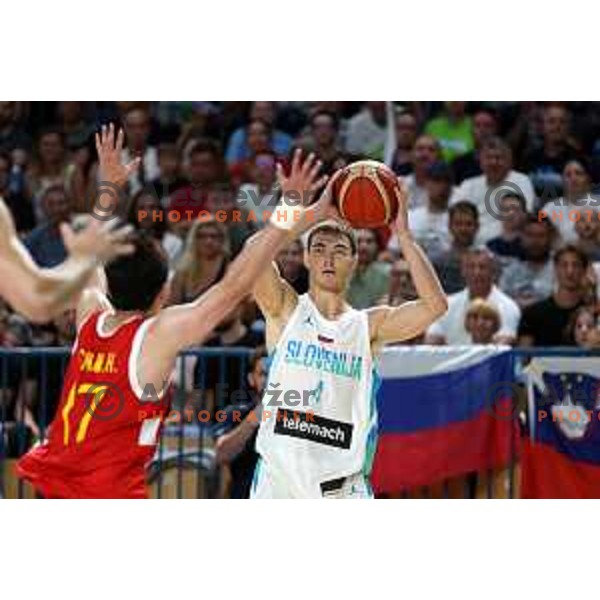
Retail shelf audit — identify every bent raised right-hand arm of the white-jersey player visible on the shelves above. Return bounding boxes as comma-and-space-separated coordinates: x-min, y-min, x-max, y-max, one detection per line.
368, 184, 448, 347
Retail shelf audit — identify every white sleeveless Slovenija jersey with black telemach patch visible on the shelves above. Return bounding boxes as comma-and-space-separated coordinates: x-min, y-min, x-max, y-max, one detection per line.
256, 294, 379, 498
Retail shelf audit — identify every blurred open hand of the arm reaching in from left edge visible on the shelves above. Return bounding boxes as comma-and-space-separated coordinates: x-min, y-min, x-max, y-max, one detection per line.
60, 217, 134, 264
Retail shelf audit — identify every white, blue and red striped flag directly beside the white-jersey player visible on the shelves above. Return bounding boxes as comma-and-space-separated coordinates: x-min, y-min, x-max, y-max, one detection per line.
372, 346, 518, 493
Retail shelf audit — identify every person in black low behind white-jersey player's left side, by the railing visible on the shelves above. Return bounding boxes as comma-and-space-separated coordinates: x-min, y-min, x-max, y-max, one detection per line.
215, 350, 267, 498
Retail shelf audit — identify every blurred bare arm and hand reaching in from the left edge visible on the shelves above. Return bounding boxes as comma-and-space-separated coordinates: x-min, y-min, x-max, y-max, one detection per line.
0, 129, 139, 322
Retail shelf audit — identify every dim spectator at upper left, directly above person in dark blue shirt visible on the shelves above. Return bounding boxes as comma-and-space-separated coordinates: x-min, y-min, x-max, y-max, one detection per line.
27, 128, 68, 222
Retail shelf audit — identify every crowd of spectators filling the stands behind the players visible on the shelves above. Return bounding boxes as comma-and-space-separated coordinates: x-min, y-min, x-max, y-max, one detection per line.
0, 101, 600, 478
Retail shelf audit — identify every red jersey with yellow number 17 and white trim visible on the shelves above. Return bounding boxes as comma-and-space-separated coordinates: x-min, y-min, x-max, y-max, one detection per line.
17, 312, 169, 498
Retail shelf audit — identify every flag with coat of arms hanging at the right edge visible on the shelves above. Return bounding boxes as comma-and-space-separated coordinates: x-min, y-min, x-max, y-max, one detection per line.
521, 357, 600, 498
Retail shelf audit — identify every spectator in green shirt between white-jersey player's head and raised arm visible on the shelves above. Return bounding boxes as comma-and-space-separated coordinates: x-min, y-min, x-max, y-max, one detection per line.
347, 229, 389, 309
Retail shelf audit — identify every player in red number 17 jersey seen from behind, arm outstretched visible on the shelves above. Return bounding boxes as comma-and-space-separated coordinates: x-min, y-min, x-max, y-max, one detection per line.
18, 125, 331, 498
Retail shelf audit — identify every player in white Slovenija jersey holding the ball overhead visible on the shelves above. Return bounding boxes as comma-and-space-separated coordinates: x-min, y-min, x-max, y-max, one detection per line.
251, 185, 447, 498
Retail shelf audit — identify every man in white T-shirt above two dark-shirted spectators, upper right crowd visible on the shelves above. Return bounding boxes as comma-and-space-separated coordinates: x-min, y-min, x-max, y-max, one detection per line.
456, 138, 535, 243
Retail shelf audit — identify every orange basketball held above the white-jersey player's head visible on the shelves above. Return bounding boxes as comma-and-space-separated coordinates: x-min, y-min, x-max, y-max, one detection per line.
333, 160, 400, 229
